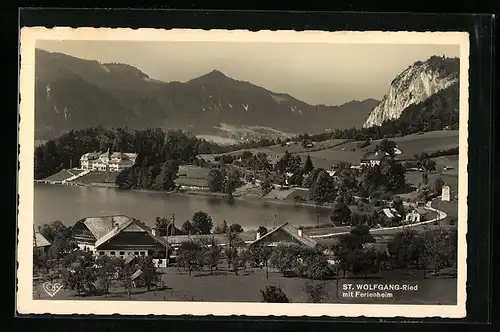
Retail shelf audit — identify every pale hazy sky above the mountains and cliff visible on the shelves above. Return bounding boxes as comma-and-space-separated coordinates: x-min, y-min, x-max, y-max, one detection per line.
36, 40, 460, 105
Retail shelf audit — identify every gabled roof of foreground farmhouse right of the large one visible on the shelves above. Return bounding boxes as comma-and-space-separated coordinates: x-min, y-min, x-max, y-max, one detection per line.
249, 223, 318, 248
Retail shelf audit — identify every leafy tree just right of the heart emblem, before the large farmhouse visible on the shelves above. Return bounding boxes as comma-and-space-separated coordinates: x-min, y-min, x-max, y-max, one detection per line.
63, 251, 97, 295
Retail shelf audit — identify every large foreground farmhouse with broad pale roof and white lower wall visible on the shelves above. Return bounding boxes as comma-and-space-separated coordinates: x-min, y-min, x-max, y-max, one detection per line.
72, 215, 167, 263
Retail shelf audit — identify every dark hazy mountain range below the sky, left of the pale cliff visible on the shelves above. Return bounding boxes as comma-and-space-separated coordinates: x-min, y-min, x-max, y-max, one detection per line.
35, 49, 379, 140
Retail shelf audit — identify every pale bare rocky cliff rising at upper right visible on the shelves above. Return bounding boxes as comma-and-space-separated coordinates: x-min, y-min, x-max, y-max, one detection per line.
363, 56, 460, 128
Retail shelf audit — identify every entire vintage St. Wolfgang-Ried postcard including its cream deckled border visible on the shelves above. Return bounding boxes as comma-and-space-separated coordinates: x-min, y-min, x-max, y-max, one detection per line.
17, 27, 469, 318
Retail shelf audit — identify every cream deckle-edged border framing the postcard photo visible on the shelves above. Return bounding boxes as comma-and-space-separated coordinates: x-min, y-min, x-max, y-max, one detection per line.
16, 27, 469, 318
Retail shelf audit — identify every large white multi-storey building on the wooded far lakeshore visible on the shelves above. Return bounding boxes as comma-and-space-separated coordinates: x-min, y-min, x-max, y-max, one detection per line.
80, 150, 137, 172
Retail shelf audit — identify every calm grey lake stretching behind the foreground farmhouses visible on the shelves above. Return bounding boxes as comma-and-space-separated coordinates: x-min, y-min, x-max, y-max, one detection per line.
34, 183, 331, 230
